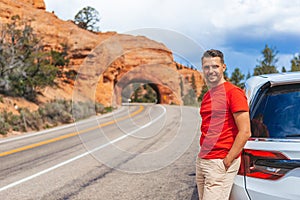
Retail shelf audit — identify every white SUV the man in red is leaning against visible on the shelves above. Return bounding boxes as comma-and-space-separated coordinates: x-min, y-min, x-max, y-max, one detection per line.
230, 72, 300, 200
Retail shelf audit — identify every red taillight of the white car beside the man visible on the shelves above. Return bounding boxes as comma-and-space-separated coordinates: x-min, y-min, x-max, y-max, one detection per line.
238, 149, 290, 180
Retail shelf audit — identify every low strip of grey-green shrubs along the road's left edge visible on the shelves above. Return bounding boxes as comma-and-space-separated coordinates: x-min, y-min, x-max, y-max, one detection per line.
0, 100, 112, 135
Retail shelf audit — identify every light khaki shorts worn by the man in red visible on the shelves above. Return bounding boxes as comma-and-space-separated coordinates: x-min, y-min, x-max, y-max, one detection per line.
196, 157, 241, 200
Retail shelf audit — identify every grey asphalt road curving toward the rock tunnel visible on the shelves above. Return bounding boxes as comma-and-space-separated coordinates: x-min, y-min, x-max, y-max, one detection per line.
0, 105, 200, 200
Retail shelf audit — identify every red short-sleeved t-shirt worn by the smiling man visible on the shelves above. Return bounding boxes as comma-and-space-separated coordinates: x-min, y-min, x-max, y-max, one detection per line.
198, 82, 249, 159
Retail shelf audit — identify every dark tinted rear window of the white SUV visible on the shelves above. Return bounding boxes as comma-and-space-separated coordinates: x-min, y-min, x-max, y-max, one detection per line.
251, 84, 300, 138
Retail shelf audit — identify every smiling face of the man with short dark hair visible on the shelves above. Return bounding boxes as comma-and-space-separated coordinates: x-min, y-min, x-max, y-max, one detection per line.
202, 57, 226, 87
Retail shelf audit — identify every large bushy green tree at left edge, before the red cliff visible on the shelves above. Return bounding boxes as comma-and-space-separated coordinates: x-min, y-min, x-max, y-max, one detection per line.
0, 16, 58, 101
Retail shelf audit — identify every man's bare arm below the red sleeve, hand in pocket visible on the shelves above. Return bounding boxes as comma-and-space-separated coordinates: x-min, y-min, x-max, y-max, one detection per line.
223, 112, 251, 170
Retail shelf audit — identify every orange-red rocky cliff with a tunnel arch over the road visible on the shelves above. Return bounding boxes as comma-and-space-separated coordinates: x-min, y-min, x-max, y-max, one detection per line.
0, 0, 203, 109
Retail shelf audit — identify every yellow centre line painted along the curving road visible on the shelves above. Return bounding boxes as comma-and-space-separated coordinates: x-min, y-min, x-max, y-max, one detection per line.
0, 106, 144, 157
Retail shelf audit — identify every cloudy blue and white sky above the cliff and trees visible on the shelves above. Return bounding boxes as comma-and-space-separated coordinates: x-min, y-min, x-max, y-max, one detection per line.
44, 0, 300, 75
